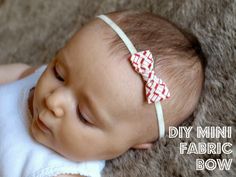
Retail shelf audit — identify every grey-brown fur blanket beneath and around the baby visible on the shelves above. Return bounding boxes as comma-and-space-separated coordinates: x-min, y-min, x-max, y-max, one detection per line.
0, 0, 236, 177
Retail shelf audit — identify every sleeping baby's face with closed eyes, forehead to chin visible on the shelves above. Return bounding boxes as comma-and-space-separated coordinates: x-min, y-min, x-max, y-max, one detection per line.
31, 19, 158, 161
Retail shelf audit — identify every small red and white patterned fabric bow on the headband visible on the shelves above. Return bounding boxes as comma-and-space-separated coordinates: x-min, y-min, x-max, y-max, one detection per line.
130, 50, 170, 103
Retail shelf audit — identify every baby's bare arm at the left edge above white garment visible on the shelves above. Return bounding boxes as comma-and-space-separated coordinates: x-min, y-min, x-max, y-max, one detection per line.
0, 63, 36, 84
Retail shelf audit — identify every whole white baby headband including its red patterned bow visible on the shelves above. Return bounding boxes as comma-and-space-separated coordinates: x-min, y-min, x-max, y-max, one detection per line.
98, 15, 170, 138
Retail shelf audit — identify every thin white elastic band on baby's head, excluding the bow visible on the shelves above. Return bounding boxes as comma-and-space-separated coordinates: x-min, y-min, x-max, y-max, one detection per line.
98, 15, 165, 138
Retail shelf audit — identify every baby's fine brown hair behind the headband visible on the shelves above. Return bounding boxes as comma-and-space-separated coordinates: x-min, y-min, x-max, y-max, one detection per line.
102, 11, 206, 126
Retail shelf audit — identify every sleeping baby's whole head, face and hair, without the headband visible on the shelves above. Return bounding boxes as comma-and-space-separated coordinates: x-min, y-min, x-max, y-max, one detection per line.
31, 12, 204, 161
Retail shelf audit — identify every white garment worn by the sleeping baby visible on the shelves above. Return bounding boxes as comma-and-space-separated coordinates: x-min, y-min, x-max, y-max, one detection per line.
0, 66, 105, 177
